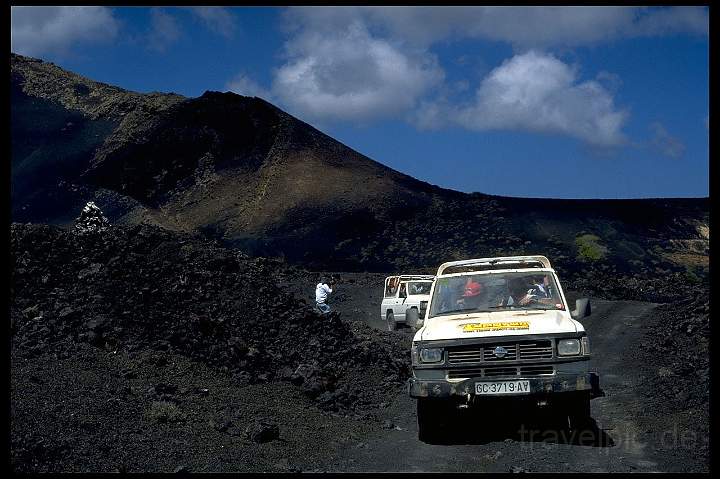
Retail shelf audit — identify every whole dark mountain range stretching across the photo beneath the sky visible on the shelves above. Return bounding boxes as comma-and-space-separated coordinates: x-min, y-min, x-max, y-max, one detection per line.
11, 55, 709, 279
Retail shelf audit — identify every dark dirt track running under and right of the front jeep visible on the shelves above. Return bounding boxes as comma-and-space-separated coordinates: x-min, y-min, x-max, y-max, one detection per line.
323, 300, 703, 472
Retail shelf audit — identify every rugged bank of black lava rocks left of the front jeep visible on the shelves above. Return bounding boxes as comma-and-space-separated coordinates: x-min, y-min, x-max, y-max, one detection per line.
11, 224, 409, 410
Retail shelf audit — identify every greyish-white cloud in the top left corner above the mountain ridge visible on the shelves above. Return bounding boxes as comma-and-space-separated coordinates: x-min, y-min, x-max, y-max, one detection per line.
10, 7, 119, 56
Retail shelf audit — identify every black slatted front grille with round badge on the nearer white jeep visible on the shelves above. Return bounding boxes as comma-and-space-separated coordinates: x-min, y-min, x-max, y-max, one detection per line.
448, 339, 553, 364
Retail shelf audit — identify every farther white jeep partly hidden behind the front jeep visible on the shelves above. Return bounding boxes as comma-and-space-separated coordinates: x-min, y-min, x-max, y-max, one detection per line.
380, 274, 435, 331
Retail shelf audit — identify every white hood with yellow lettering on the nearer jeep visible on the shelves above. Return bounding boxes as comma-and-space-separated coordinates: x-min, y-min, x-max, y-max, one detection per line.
422, 311, 584, 341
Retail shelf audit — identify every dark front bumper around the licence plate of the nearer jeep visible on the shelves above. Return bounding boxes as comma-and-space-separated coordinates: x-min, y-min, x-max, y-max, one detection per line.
408, 372, 604, 398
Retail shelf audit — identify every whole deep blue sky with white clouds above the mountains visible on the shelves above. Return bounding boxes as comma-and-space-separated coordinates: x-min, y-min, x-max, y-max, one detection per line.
11, 7, 709, 198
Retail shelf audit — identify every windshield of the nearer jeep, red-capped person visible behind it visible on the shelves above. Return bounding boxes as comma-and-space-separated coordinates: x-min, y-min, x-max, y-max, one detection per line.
428, 271, 565, 318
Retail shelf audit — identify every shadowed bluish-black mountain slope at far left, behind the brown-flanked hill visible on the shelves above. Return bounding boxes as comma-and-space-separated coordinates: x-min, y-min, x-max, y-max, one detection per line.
10, 54, 183, 223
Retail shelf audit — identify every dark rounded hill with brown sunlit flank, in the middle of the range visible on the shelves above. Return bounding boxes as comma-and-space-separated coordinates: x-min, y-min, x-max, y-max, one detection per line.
83, 92, 444, 238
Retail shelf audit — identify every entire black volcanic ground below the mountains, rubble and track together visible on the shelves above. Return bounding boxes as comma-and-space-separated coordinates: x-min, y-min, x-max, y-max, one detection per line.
10, 224, 709, 472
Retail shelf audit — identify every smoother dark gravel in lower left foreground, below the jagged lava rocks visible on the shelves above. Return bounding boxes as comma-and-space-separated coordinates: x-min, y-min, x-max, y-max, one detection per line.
11, 343, 386, 472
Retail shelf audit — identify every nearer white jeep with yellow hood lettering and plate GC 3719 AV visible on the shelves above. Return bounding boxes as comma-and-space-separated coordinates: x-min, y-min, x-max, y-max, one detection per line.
408, 256, 602, 442
